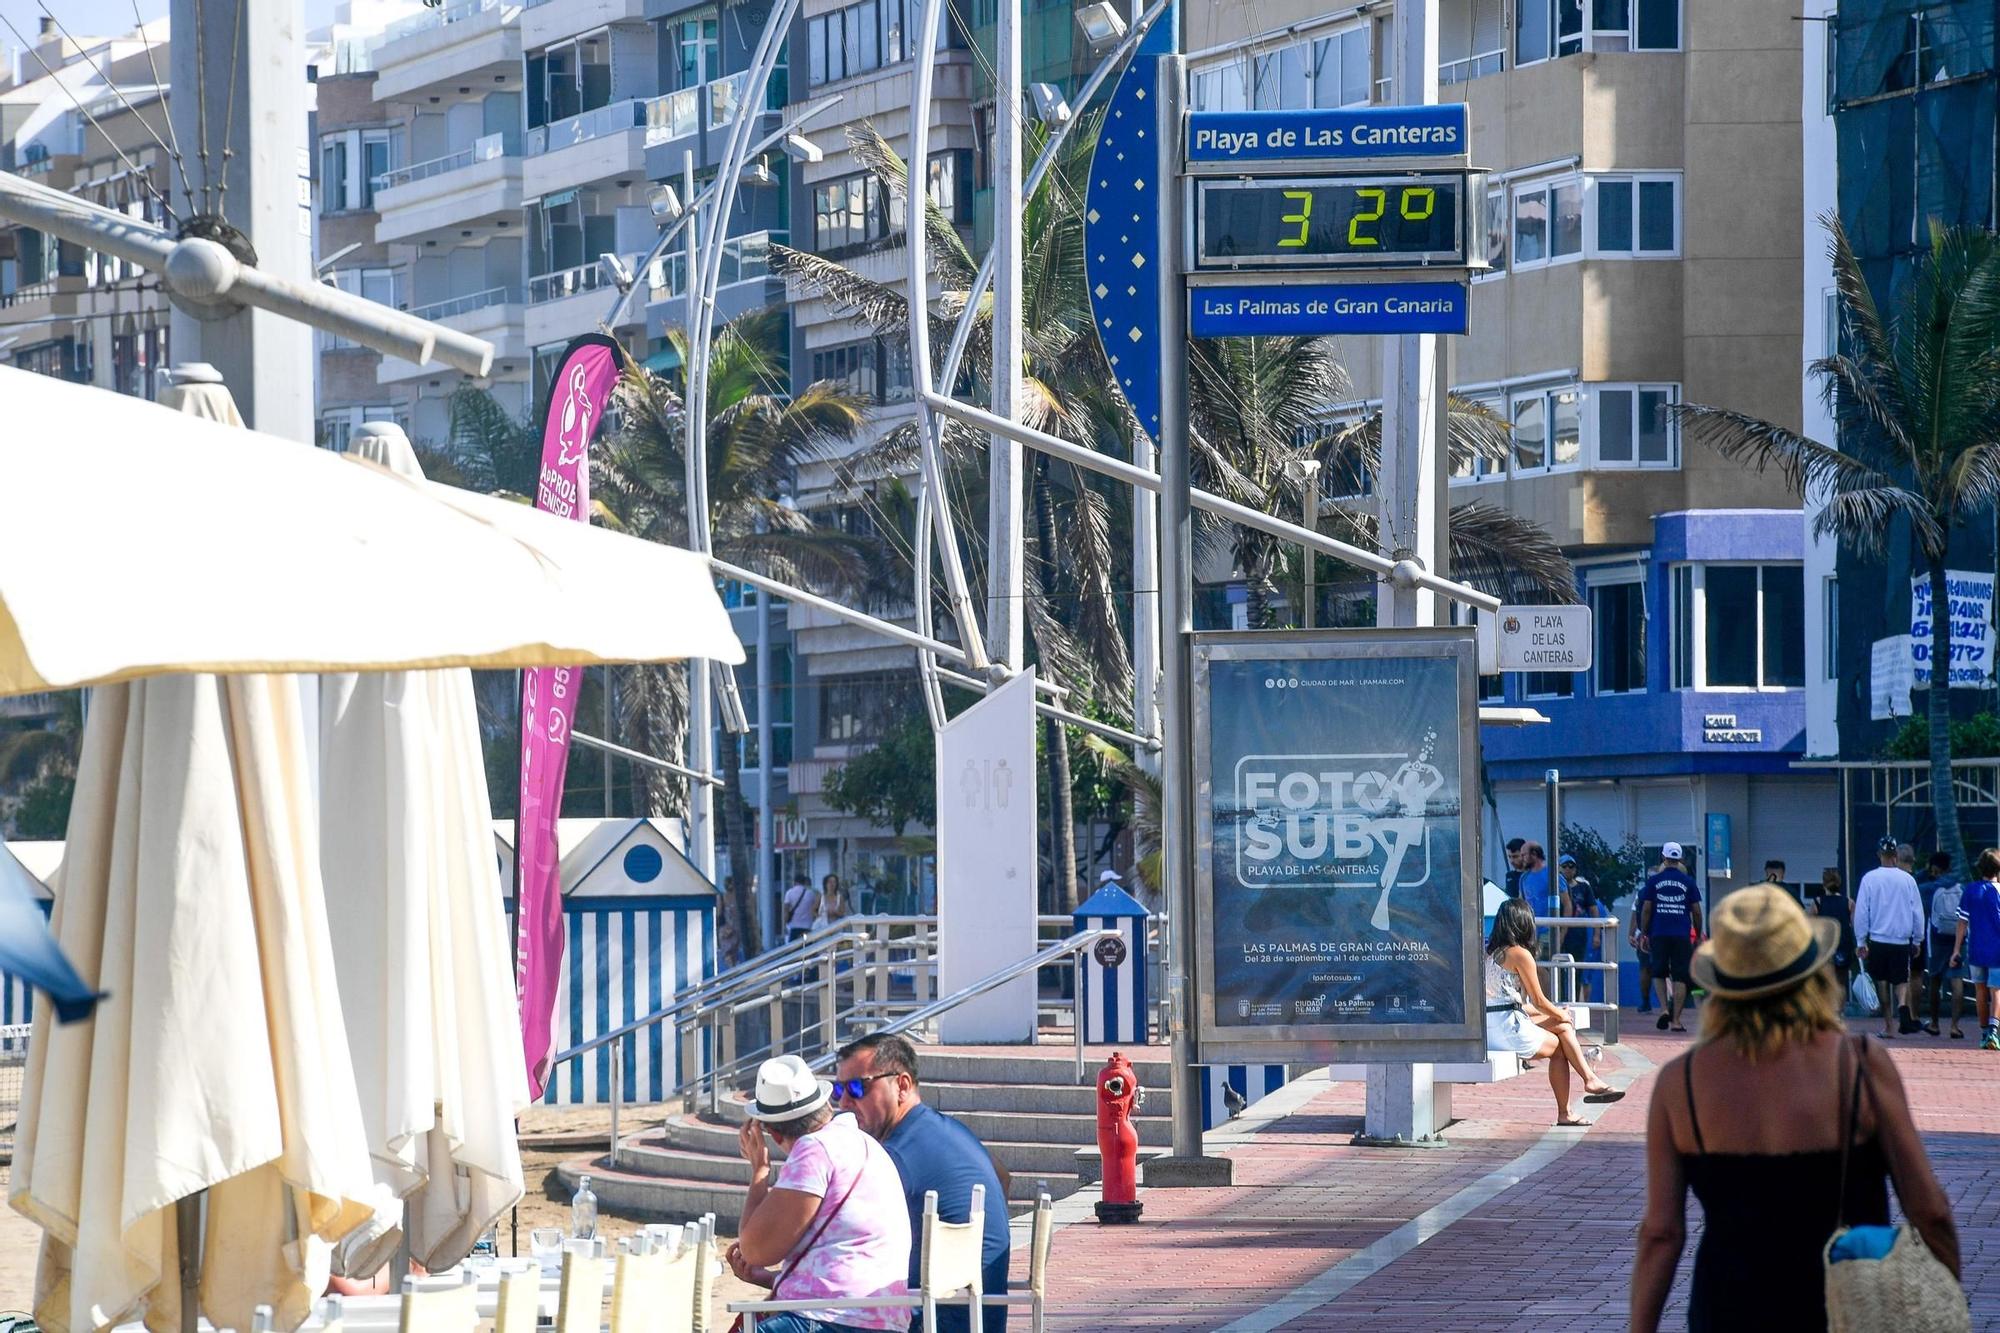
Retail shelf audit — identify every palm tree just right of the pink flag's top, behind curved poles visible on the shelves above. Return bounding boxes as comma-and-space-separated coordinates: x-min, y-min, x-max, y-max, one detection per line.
594, 310, 878, 955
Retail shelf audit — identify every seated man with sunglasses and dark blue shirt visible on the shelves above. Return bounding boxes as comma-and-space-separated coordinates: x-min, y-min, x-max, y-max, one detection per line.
834, 1033, 1010, 1333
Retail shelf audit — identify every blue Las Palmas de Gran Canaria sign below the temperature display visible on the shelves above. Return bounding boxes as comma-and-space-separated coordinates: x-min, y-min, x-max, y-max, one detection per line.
1188, 278, 1470, 338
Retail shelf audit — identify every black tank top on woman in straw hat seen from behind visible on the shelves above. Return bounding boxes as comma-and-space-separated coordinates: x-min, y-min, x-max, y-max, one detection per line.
1680, 1037, 1888, 1333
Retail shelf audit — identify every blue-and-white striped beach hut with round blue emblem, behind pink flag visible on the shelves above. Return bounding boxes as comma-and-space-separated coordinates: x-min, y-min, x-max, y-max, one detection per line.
494, 819, 716, 1103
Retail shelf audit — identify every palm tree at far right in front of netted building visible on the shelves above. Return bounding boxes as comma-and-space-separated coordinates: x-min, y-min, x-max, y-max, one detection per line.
1678, 218, 2000, 871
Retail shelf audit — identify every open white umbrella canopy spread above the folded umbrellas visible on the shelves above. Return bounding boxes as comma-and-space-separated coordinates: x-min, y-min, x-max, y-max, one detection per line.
0, 368, 744, 695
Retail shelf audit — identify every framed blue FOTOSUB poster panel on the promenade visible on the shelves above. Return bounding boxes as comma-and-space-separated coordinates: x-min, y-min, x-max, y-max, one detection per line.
1194, 628, 1486, 1063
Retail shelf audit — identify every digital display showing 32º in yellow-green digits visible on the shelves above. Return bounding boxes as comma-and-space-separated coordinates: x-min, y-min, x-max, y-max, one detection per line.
1194, 172, 1484, 268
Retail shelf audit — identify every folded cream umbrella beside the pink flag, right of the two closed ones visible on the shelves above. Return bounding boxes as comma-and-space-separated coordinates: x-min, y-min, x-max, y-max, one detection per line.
320, 426, 528, 1271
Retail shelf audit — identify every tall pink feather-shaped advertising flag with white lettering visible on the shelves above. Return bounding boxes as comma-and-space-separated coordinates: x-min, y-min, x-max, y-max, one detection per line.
514, 334, 622, 1097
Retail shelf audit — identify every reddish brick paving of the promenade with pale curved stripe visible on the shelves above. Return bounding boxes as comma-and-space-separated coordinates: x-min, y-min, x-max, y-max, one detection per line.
1024, 1012, 2000, 1333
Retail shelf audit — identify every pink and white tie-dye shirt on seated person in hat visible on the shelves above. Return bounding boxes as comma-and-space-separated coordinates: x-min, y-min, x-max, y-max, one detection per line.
772, 1113, 910, 1333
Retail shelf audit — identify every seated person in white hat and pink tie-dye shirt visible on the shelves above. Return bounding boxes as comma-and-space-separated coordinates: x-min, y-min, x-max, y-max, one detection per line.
726, 1055, 910, 1333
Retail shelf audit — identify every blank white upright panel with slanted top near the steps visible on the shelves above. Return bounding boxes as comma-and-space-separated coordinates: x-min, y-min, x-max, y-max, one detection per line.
938, 669, 1040, 1043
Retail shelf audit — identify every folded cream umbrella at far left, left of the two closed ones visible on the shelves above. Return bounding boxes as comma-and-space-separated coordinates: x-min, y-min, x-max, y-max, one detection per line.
8, 675, 374, 1333
